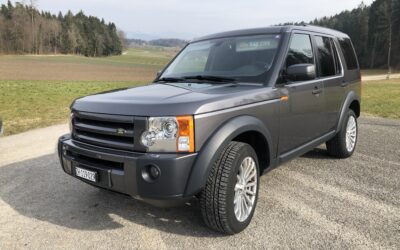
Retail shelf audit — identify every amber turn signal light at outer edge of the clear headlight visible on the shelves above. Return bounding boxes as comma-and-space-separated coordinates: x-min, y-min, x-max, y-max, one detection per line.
176, 116, 194, 153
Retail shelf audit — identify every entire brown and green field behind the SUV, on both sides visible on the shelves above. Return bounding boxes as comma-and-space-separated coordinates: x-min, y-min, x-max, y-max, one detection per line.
0, 48, 400, 135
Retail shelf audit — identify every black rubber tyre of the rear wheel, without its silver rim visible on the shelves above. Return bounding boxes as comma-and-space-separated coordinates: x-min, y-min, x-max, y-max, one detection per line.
326, 109, 358, 158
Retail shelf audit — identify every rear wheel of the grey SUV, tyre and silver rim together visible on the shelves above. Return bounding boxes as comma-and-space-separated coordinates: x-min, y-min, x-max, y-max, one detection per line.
326, 109, 358, 159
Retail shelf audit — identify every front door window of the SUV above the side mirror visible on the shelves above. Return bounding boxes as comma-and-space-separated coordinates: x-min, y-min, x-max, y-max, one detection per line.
286, 34, 314, 67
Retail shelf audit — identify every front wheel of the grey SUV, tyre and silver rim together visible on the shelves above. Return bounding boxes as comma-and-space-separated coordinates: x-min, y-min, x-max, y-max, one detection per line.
200, 142, 260, 234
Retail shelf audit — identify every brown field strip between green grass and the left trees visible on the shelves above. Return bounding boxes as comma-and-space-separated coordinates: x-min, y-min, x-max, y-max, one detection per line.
0, 48, 177, 81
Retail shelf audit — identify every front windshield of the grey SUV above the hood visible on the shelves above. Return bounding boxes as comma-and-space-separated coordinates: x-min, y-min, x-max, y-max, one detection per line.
160, 34, 281, 83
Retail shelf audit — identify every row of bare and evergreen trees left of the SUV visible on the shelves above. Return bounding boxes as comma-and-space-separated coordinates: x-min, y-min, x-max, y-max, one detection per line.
0, 1, 124, 57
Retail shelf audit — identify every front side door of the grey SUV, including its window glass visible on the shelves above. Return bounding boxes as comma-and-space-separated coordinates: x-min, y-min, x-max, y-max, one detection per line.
278, 33, 326, 154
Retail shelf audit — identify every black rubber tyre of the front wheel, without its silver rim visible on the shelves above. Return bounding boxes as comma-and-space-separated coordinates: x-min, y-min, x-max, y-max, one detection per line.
200, 142, 260, 234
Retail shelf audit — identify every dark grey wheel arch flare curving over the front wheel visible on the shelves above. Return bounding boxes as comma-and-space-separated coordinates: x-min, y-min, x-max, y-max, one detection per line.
185, 115, 273, 196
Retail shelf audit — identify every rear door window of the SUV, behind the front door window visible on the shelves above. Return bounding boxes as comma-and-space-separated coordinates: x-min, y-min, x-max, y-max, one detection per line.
315, 36, 336, 77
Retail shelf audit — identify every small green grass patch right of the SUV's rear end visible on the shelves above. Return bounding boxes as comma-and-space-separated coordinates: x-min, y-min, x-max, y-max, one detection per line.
361, 79, 400, 119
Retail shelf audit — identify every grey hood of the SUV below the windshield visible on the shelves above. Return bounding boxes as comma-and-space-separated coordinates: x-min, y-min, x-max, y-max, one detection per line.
71, 83, 279, 116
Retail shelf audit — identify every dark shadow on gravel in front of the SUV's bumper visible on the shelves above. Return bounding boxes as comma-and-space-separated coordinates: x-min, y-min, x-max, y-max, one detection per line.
0, 154, 223, 237
